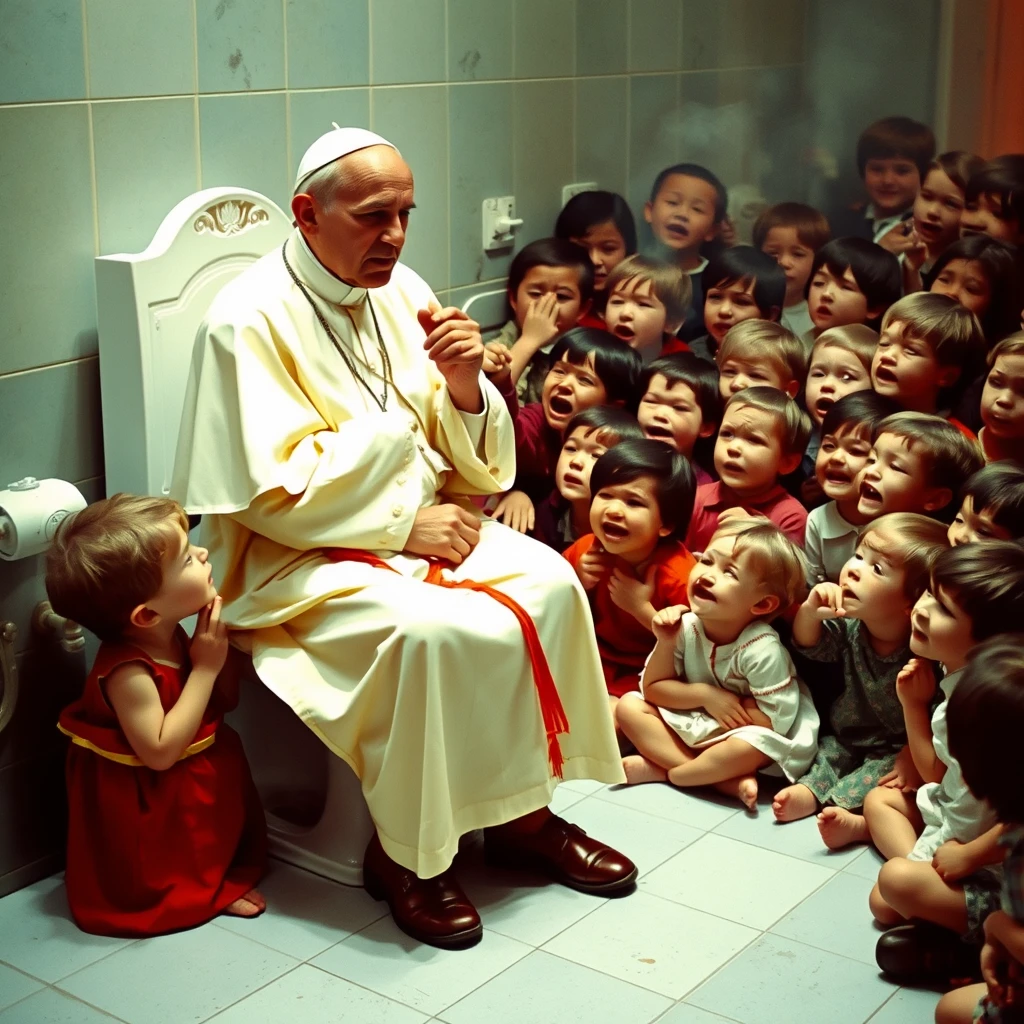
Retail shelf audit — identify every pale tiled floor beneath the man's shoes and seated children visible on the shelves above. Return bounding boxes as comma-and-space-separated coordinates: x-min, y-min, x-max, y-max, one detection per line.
0, 782, 937, 1024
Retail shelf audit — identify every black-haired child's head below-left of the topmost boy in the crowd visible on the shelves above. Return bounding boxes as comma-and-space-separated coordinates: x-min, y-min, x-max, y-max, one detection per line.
807, 238, 902, 334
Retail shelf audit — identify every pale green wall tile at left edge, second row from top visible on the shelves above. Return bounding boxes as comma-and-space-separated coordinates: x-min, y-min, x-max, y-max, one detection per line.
0, 104, 96, 376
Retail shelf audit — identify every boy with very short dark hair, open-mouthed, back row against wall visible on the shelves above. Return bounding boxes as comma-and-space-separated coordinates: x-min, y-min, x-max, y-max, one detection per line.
643, 164, 729, 341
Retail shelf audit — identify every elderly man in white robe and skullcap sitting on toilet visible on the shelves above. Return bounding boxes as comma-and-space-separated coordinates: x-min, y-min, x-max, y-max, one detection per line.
173, 128, 636, 948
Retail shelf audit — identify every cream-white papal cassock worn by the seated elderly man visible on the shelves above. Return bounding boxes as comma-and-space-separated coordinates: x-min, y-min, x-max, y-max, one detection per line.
172, 230, 624, 878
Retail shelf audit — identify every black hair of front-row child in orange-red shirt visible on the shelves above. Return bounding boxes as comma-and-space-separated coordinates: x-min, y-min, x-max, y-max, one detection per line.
590, 437, 696, 540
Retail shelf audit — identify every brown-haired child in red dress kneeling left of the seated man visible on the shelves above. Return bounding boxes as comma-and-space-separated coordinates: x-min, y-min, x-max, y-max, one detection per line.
46, 495, 266, 936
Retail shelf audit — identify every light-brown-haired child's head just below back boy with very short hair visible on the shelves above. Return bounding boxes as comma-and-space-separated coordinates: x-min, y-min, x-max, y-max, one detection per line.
604, 256, 691, 362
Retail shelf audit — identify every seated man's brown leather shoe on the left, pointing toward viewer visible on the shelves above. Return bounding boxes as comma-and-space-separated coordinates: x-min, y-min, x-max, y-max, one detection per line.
362, 833, 483, 949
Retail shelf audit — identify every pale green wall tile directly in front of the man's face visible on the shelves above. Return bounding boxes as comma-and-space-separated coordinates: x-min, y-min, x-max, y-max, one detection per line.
373, 85, 449, 291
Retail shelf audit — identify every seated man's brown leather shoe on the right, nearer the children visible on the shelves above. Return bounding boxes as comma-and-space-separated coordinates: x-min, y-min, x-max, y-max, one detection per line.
484, 815, 637, 896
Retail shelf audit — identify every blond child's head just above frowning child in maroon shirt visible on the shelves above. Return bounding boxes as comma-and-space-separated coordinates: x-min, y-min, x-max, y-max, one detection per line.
715, 319, 807, 401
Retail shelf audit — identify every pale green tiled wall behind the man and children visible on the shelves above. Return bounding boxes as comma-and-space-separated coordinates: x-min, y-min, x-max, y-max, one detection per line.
0, 0, 807, 892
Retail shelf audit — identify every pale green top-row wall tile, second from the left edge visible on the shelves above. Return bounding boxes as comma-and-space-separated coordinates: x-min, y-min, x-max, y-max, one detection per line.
85, 0, 196, 96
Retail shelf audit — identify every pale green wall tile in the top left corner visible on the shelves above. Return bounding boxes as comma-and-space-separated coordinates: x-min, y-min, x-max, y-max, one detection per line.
0, 0, 85, 103
